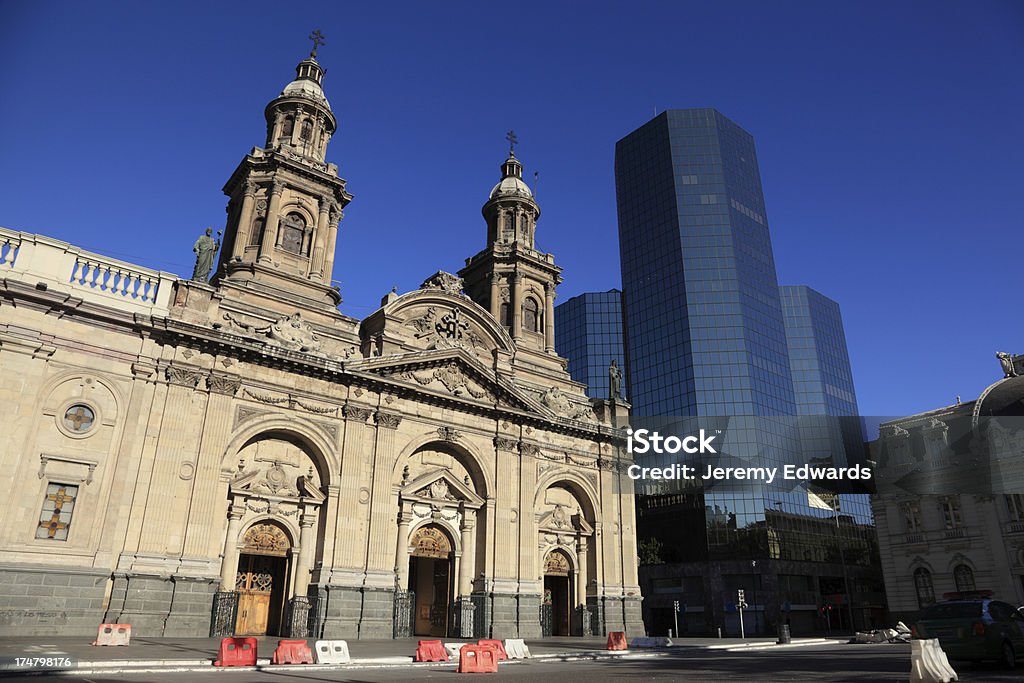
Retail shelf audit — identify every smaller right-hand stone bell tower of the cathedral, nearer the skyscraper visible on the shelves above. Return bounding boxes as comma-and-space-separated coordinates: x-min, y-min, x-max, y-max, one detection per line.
459, 132, 562, 355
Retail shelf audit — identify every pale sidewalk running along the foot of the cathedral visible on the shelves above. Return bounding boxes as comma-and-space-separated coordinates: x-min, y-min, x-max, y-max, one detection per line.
0, 636, 828, 675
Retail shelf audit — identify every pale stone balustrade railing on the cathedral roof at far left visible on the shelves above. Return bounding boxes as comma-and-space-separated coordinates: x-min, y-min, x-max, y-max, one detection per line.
0, 227, 178, 315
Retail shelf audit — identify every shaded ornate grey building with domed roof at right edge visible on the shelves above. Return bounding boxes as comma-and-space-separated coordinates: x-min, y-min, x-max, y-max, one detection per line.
870, 353, 1024, 624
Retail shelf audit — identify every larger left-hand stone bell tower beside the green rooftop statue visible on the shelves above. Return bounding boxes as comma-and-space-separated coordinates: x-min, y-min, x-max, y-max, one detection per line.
212, 37, 352, 308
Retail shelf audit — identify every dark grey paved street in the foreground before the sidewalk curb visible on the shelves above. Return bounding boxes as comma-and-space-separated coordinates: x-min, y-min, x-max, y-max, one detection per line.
2, 642, 1020, 683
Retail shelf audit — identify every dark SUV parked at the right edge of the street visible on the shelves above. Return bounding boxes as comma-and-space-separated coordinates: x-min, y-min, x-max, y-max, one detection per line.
911, 598, 1024, 669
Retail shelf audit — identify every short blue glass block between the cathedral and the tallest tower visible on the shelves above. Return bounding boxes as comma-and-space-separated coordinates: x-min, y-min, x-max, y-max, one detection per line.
555, 290, 629, 399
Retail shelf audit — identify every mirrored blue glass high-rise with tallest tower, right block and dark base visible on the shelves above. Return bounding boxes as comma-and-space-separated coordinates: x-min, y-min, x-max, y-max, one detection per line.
615, 109, 882, 634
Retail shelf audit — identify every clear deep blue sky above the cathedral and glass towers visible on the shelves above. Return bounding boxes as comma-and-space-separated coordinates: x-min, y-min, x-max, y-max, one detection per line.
0, 0, 1024, 415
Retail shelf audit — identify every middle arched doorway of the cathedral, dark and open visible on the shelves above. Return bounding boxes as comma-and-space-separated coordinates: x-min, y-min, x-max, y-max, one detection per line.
409, 524, 455, 637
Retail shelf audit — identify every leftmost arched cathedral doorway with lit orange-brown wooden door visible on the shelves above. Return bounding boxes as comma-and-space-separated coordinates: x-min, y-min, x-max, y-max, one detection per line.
234, 522, 292, 636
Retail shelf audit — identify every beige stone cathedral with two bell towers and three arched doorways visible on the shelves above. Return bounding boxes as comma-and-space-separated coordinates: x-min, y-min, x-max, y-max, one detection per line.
0, 53, 643, 638
